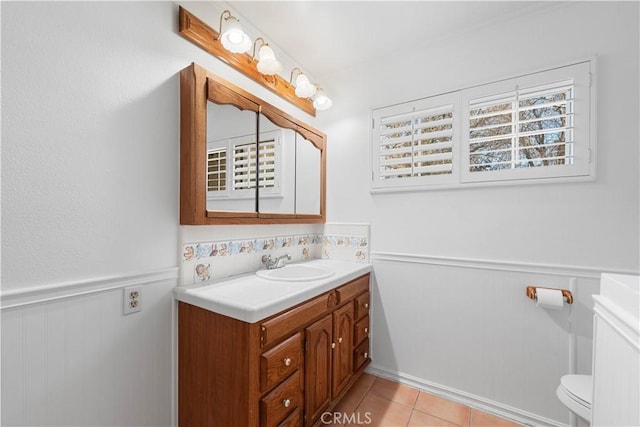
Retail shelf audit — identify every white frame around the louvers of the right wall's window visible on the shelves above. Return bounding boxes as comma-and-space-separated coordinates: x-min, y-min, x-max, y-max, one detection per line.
369, 57, 597, 193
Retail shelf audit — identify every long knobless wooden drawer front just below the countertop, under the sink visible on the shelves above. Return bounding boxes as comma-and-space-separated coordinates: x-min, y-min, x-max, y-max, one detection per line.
260, 291, 337, 347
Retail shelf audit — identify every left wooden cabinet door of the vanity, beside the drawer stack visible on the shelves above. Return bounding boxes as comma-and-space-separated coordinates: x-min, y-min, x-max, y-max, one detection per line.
304, 314, 332, 425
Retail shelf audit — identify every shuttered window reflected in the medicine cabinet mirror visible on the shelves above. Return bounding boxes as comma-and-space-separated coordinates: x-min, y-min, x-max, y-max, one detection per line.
207, 131, 280, 199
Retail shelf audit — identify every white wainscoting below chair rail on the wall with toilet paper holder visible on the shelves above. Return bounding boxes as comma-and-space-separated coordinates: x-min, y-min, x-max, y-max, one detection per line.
371, 252, 599, 425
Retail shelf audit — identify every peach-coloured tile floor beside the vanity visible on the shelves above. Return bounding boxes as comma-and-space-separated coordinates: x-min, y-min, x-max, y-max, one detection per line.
323, 373, 520, 427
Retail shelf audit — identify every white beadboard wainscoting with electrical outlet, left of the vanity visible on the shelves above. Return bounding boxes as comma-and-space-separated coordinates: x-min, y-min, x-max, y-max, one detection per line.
1, 269, 177, 426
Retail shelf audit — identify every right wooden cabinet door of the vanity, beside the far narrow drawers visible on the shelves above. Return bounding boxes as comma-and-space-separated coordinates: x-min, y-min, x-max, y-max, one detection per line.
332, 302, 354, 397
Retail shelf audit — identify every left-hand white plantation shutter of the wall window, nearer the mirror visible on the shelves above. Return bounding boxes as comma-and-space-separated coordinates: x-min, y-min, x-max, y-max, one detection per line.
372, 91, 457, 188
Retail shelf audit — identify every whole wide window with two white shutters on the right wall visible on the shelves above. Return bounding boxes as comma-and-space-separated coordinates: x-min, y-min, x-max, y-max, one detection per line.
371, 61, 595, 191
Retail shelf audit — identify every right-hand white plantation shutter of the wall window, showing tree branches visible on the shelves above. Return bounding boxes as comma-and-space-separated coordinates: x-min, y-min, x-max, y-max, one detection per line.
461, 62, 594, 182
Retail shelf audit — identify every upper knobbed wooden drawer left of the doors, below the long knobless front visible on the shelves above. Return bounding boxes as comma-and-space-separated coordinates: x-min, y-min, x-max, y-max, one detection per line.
260, 332, 302, 392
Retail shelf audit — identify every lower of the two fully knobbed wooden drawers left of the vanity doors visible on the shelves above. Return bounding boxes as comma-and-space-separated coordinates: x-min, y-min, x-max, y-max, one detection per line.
260, 371, 302, 427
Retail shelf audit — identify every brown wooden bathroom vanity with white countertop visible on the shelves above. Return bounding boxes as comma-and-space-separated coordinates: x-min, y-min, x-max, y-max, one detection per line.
176, 260, 370, 426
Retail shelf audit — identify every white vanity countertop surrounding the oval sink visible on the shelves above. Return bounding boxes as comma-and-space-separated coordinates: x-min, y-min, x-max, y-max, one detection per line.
174, 259, 371, 323
